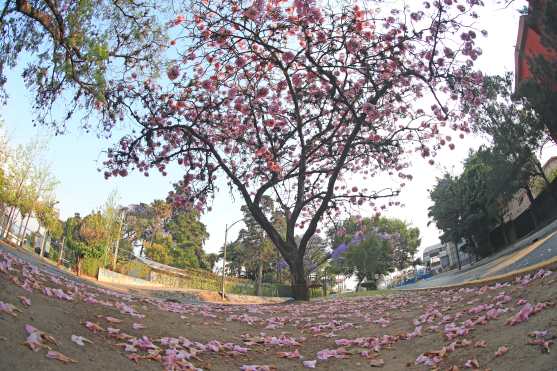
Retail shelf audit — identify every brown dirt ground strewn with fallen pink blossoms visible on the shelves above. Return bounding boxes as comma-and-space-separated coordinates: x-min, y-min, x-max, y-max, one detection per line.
0, 247, 557, 371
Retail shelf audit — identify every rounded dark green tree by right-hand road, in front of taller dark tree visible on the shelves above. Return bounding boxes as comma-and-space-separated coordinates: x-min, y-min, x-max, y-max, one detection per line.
429, 146, 531, 256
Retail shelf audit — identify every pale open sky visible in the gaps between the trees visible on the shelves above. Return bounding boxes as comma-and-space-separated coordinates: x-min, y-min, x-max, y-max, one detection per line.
0, 1, 555, 252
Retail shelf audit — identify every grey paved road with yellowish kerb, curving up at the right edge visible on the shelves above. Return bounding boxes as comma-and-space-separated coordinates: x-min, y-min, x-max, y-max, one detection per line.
402, 221, 557, 289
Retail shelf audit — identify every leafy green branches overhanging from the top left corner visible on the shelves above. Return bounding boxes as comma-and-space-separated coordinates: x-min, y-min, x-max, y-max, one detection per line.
0, 0, 168, 131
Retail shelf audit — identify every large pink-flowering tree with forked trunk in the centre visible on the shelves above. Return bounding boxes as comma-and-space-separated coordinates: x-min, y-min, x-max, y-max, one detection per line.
5, 0, 482, 299
